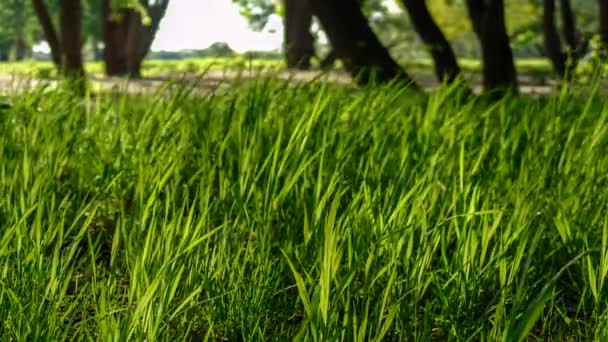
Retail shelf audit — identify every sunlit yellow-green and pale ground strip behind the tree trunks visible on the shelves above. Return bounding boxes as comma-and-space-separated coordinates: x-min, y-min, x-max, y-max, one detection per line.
0, 57, 555, 96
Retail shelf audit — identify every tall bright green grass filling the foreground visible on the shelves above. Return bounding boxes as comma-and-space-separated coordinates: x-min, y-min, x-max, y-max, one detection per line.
0, 79, 608, 341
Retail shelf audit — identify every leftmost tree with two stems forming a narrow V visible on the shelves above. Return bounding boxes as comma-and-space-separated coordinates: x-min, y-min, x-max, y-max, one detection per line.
32, 0, 84, 77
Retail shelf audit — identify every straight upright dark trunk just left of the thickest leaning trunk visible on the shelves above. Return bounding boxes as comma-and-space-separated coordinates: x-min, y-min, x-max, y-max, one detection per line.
283, 0, 315, 70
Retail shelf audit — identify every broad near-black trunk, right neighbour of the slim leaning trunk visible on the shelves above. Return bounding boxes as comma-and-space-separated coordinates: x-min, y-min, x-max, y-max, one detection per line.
467, 0, 517, 92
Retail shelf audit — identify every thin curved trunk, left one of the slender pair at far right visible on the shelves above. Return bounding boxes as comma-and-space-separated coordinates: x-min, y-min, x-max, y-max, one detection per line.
543, 0, 566, 77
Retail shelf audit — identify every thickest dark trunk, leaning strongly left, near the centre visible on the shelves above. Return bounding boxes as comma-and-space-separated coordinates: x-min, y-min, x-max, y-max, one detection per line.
308, 0, 414, 84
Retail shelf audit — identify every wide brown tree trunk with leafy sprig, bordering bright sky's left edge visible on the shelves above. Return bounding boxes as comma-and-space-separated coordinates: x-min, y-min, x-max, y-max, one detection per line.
101, 0, 169, 78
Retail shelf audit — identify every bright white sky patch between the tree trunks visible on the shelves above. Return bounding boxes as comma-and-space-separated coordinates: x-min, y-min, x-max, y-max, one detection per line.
152, 0, 283, 52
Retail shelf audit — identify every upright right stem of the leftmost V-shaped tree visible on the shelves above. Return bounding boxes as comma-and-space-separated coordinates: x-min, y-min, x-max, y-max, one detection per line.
59, 0, 84, 78
